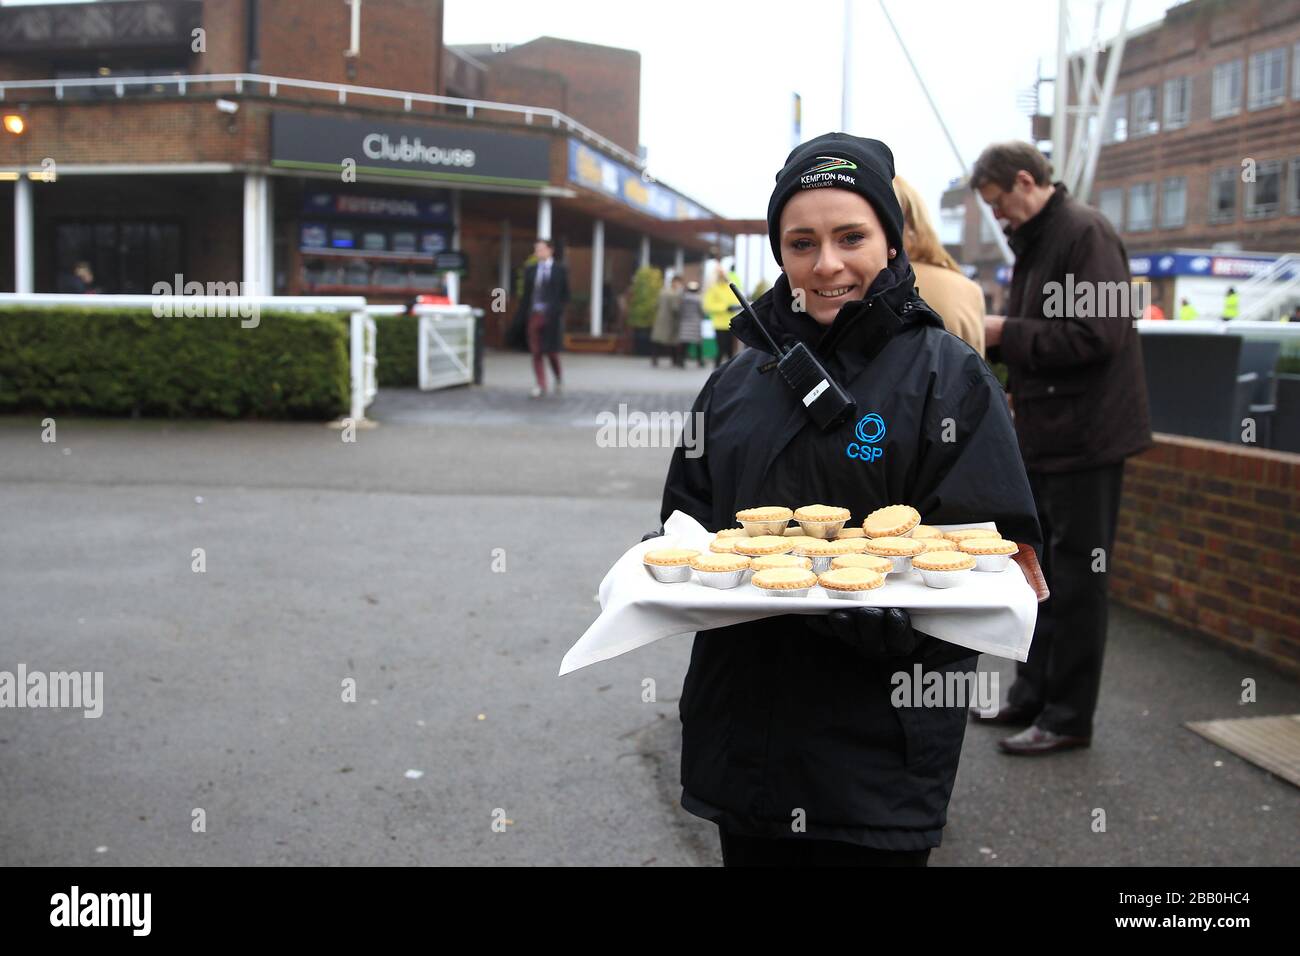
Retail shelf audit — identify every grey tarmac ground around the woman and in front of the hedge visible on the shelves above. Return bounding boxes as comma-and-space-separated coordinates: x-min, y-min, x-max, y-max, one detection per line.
0, 354, 1300, 866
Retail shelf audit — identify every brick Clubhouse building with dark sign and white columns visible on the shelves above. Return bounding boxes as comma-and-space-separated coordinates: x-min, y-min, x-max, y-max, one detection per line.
0, 0, 733, 342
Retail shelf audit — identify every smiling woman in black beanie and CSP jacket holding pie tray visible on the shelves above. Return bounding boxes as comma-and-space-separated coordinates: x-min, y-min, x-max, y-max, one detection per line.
644, 133, 1039, 865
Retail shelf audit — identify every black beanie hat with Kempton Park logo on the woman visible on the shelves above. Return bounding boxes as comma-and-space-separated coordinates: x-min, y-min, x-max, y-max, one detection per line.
767, 133, 902, 264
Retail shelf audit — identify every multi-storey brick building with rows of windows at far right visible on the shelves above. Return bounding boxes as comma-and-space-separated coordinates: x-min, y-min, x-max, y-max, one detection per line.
1089, 0, 1300, 317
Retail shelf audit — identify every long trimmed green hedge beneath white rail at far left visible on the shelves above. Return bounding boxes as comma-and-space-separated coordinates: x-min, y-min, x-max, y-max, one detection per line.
0, 307, 351, 420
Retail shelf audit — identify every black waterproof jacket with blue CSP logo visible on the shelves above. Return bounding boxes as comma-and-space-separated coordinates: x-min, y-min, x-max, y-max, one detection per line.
660, 256, 1039, 849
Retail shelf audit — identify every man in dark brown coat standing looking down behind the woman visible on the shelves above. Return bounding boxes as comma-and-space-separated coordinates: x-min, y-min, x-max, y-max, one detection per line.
971, 143, 1152, 754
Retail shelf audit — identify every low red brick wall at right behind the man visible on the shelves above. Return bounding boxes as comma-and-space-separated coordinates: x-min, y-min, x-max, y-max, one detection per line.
1110, 434, 1300, 674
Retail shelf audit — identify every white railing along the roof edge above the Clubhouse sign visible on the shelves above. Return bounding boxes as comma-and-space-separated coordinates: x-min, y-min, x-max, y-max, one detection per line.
0, 73, 645, 170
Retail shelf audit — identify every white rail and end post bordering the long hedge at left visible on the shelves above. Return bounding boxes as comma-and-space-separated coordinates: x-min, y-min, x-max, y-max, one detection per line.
0, 293, 377, 421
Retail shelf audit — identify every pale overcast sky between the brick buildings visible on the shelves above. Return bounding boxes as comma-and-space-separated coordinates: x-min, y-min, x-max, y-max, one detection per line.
443, 0, 1175, 274
